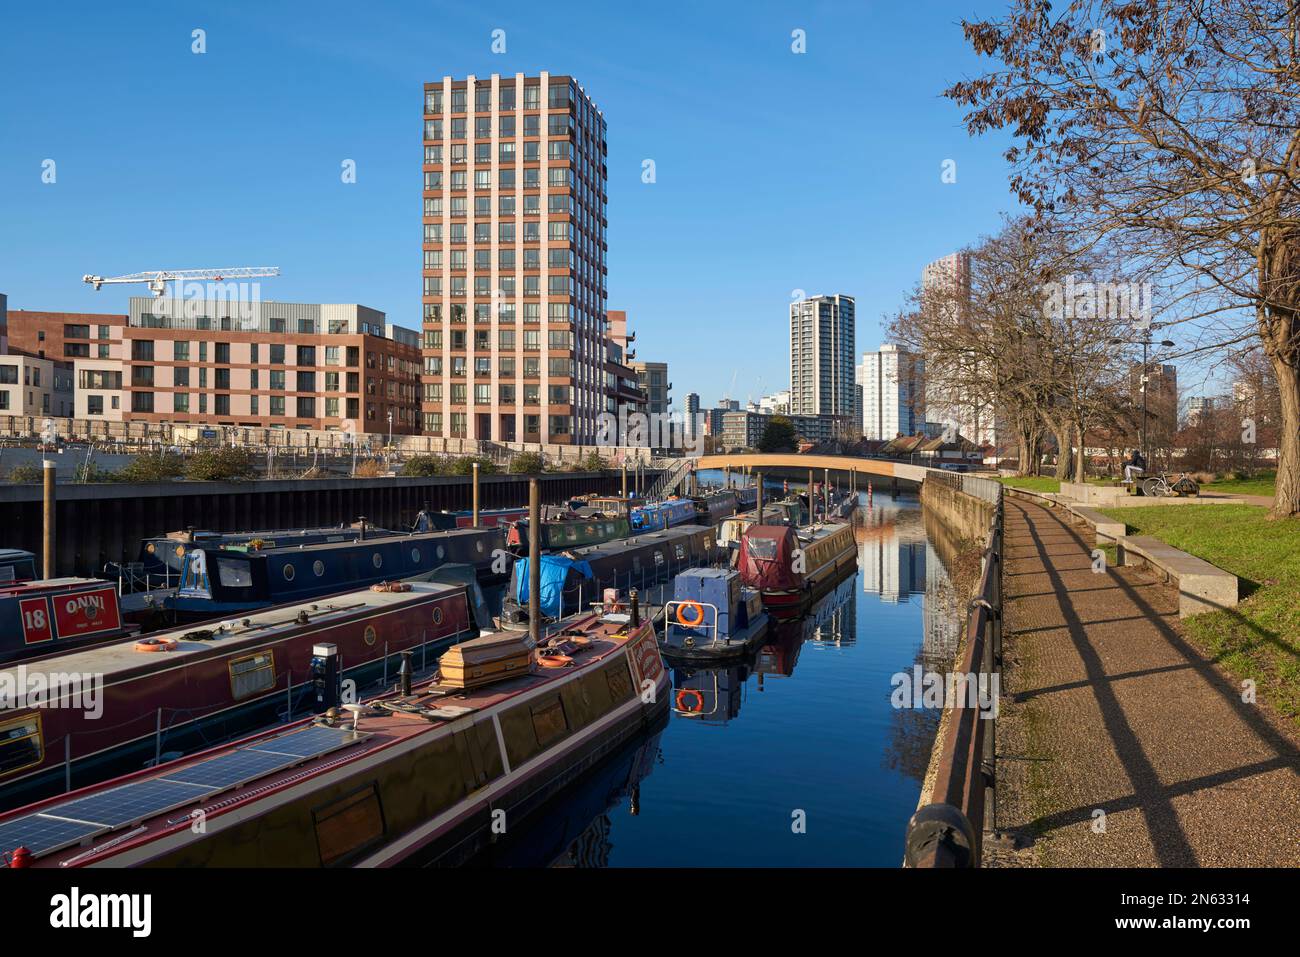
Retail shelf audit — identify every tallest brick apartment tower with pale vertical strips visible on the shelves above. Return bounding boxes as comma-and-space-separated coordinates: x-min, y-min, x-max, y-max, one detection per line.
421, 73, 608, 443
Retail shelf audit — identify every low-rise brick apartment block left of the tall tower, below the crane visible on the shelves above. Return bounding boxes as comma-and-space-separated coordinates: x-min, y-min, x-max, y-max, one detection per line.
116, 296, 420, 434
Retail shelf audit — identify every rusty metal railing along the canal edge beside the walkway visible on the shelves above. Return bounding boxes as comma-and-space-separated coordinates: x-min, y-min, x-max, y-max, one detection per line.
904, 486, 1002, 867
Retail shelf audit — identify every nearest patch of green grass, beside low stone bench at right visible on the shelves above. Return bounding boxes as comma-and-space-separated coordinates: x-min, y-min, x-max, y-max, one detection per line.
1101, 505, 1300, 726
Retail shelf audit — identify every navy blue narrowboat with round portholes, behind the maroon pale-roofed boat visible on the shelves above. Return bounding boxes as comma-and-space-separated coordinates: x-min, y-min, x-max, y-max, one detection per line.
157, 528, 510, 622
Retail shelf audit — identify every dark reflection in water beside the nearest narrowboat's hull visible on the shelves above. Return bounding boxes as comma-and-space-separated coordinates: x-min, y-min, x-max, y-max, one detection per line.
465, 711, 668, 867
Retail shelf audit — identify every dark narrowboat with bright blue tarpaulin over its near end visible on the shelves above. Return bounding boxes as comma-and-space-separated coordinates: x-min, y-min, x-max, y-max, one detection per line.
499, 525, 719, 631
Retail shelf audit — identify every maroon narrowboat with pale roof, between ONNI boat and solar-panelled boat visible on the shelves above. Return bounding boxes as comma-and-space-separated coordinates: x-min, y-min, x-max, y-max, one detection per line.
0, 583, 477, 807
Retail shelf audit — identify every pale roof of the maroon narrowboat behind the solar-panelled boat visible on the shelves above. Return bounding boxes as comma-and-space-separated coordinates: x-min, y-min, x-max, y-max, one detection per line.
0, 581, 465, 687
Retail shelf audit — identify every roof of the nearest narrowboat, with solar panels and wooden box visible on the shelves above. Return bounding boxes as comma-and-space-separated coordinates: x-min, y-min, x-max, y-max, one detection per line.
0, 615, 644, 867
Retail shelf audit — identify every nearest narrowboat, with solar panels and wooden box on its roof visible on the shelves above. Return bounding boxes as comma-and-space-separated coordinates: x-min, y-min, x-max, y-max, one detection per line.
0, 615, 670, 867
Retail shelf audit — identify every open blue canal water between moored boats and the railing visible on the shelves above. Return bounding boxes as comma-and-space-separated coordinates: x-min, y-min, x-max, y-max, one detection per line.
475, 475, 959, 867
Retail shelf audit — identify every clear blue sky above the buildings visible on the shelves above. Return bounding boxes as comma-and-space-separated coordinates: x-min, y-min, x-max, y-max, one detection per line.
0, 0, 1013, 407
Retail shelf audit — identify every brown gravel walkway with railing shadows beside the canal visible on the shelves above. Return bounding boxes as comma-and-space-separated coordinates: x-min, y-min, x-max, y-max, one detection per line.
997, 497, 1300, 867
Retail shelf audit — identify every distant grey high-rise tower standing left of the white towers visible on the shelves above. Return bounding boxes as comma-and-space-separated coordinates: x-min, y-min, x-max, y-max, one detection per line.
790, 295, 855, 417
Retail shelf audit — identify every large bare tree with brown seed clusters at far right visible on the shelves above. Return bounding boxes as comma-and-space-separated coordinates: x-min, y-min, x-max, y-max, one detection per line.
946, 0, 1300, 516
